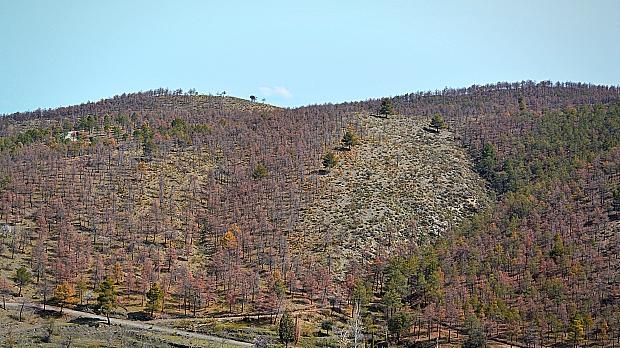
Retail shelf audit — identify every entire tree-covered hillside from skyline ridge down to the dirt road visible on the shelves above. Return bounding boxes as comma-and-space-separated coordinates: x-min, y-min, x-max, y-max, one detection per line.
0, 82, 620, 346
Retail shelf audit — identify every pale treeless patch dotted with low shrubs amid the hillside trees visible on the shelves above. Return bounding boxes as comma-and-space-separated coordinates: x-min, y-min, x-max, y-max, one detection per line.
297, 115, 489, 270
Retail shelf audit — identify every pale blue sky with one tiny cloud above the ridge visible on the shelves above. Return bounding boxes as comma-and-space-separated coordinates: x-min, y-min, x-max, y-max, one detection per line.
0, 0, 620, 113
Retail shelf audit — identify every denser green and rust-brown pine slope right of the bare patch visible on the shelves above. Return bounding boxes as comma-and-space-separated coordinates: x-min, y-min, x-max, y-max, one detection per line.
354, 103, 620, 345
